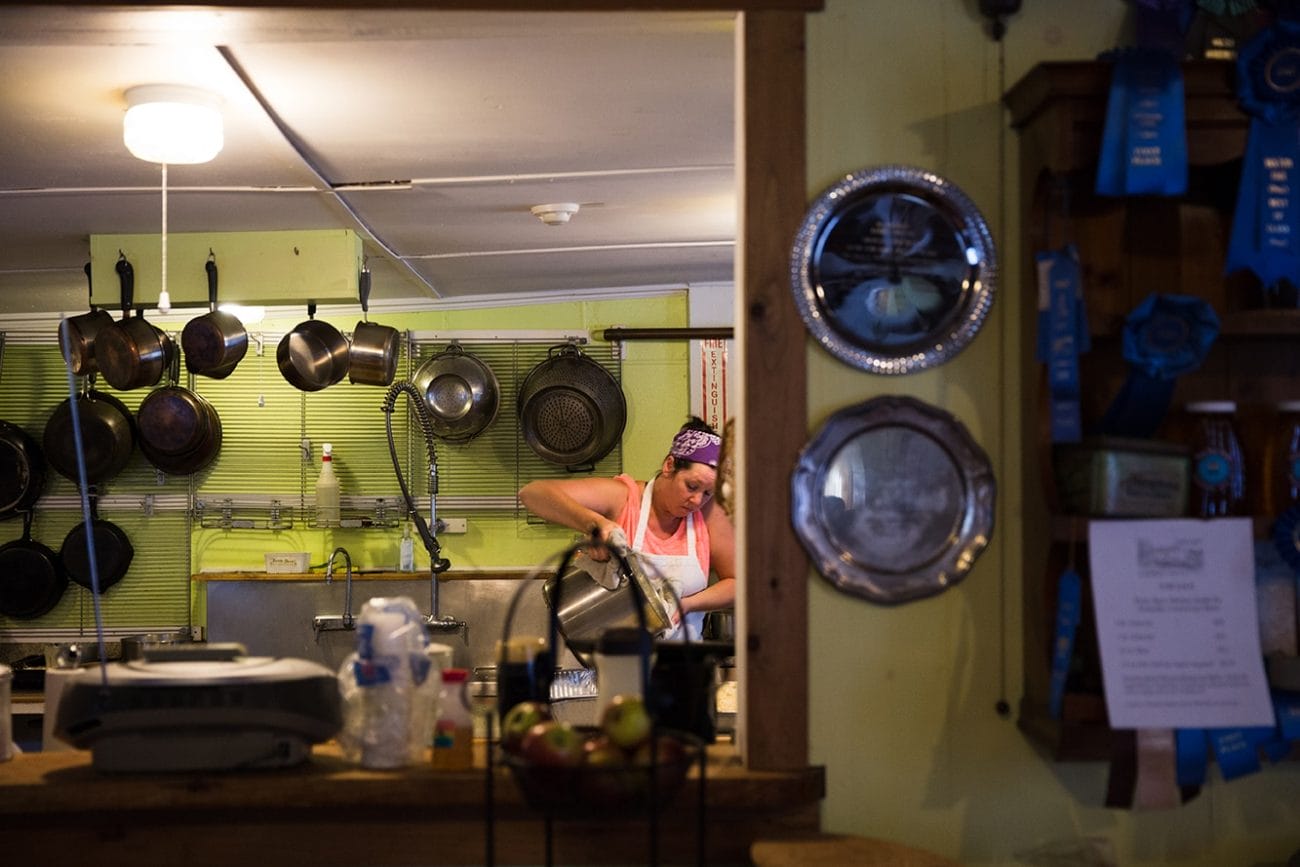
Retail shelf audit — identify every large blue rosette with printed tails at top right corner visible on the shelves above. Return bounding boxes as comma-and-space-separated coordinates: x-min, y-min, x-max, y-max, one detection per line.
1225, 19, 1300, 286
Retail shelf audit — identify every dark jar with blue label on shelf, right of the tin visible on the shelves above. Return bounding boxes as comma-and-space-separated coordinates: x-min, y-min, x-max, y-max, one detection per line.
1187, 400, 1248, 517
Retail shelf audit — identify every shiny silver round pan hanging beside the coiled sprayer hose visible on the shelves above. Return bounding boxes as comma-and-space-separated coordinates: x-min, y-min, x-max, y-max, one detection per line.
413, 341, 501, 442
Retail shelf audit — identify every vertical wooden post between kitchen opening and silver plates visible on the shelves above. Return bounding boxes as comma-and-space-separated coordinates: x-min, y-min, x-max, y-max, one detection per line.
736, 12, 809, 770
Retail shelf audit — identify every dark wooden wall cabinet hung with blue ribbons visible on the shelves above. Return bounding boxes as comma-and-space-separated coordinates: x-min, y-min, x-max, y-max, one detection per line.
1005, 61, 1300, 759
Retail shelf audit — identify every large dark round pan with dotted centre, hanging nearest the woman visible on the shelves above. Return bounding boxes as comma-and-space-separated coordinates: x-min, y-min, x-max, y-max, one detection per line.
519, 343, 628, 471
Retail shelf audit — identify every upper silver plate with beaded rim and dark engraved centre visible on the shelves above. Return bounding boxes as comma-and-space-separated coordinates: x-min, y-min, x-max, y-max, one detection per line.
790, 165, 997, 373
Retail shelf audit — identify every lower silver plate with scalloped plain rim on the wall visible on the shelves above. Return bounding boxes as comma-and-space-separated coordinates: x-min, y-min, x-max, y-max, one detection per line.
792, 396, 996, 604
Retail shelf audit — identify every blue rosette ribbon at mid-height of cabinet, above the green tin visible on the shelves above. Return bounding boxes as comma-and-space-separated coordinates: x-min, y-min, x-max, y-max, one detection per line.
1101, 294, 1219, 438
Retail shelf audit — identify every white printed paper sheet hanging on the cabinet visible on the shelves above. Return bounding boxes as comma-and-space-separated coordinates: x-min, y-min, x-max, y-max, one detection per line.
1088, 519, 1274, 728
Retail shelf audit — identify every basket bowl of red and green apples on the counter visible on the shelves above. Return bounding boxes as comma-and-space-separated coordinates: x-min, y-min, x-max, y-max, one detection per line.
501, 695, 702, 815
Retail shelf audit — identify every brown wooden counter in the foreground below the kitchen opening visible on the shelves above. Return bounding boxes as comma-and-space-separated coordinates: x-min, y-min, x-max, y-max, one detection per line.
0, 742, 826, 867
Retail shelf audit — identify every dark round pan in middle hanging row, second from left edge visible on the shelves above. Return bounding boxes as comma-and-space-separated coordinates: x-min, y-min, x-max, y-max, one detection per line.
42, 377, 135, 485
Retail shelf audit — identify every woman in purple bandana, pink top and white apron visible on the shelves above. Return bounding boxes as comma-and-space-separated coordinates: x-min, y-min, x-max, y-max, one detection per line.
519, 417, 736, 640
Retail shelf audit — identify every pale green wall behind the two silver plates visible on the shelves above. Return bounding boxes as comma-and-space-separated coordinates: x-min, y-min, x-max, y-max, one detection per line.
811, 0, 1300, 867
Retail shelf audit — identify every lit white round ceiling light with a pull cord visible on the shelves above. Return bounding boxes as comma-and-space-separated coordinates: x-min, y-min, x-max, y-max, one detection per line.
122, 84, 225, 165
